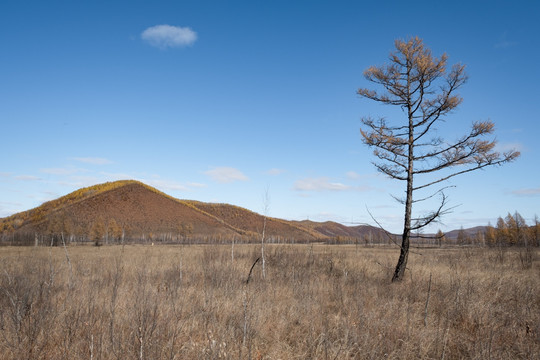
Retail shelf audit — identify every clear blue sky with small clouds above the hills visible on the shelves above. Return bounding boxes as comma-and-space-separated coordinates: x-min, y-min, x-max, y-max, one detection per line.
0, 0, 540, 232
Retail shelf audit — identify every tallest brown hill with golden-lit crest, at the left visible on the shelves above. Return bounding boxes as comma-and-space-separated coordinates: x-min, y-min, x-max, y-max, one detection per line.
3, 181, 243, 240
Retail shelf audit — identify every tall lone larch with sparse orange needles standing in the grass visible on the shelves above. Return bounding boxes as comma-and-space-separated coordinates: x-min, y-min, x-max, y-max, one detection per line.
358, 37, 519, 281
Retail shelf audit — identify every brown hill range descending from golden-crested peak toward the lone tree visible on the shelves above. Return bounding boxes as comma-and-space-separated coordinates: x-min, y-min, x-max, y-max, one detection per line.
0, 180, 383, 242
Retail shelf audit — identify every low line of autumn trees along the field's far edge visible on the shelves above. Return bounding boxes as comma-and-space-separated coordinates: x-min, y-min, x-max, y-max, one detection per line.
0, 211, 540, 247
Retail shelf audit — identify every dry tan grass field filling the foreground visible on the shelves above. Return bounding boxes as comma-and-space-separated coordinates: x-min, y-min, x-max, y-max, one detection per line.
0, 245, 540, 359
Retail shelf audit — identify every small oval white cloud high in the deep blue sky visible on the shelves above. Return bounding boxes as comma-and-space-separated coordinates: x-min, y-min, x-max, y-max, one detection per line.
141, 25, 197, 49
